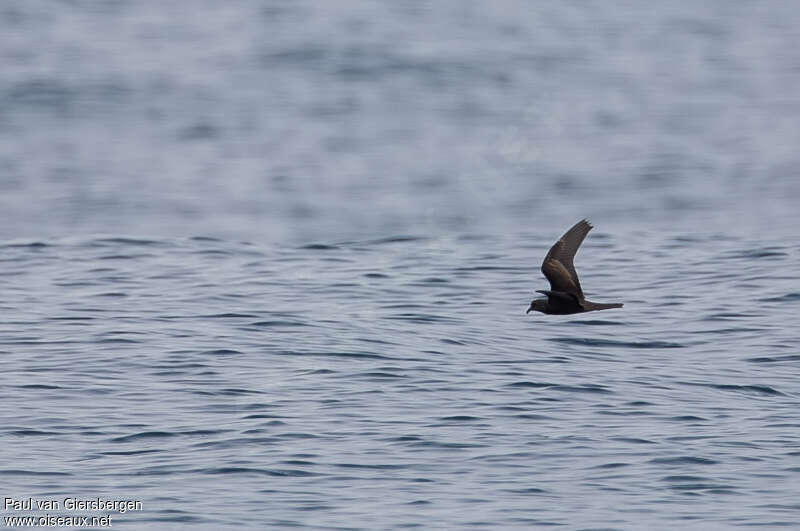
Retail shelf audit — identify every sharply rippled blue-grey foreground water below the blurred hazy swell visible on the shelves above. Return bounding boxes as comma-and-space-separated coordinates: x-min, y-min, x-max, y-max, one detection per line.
0, 235, 800, 529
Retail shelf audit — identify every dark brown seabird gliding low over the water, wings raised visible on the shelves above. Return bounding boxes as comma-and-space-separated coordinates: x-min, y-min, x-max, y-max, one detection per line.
525, 219, 622, 315
